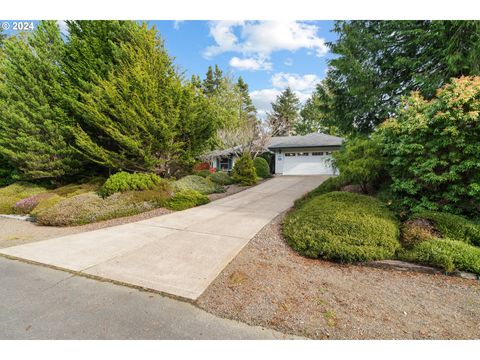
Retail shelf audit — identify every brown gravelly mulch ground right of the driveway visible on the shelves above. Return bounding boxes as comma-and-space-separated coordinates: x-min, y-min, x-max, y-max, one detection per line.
197, 212, 480, 339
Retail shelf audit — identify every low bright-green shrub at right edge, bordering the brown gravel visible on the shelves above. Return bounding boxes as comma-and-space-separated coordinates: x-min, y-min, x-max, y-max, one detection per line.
398, 239, 480, 274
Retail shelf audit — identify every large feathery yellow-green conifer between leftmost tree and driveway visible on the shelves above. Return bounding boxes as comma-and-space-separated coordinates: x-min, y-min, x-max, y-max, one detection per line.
71, 24, 217, 176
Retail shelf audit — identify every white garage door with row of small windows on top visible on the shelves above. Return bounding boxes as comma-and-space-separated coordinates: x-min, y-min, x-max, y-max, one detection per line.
283, 151, 334, 175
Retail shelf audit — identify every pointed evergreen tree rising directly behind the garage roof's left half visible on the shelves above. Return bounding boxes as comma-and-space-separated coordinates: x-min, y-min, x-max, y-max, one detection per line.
267, 87, 300, 136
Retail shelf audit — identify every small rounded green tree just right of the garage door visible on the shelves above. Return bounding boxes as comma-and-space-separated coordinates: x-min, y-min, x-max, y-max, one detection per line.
333, 137, 385, 194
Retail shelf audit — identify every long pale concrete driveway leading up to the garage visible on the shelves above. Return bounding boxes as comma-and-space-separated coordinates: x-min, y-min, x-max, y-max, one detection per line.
0, 176, 328, 300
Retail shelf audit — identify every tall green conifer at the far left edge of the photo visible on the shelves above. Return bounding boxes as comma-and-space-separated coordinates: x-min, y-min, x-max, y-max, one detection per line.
0, 21, 80, 179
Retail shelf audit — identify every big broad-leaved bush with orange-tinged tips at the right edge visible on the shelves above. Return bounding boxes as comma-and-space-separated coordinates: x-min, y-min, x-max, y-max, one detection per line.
376, 77, 480, 216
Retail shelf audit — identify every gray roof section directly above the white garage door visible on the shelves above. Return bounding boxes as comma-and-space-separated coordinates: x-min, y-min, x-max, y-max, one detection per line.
267, 133, 343, 149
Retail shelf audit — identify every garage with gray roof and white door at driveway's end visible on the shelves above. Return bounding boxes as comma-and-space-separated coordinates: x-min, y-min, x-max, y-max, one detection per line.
268, 133, 343, 175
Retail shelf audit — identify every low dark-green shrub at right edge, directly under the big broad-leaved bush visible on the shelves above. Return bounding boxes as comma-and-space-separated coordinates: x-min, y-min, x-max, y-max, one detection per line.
412, 211, 480, 246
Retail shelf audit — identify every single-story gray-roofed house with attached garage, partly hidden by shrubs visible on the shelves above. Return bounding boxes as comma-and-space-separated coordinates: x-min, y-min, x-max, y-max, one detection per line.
208, 133, 343, 175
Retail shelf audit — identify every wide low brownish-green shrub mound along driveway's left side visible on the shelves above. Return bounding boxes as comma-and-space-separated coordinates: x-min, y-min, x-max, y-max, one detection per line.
36, 191, 165, 226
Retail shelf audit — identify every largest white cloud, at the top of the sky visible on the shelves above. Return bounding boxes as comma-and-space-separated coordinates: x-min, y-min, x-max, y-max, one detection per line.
203, 21, 328, 58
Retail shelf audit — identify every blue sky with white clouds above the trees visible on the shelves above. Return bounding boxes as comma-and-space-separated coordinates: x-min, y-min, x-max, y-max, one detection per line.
0, 20, 336, 117
